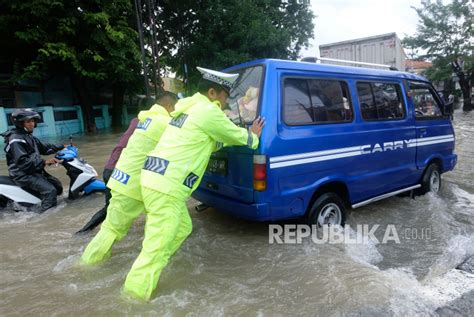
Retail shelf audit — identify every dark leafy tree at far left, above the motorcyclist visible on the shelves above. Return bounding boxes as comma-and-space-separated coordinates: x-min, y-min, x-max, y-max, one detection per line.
0, 0, 140, 131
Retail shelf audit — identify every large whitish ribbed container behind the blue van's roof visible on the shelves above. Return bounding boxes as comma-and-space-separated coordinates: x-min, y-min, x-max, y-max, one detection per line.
319, 33, 406, 71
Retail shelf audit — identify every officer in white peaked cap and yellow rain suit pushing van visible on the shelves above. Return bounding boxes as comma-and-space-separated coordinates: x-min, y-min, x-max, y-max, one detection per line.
123, 67, 264, 300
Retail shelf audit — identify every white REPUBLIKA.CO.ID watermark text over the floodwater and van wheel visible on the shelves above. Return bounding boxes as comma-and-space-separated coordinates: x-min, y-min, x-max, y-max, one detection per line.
268, 224, 431, 244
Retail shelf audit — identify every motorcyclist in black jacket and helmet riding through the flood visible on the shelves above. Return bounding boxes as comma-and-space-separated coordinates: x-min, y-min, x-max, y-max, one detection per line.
1, 109, 64, 212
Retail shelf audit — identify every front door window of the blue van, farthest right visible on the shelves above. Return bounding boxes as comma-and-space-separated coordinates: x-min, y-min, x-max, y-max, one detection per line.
410, 83, 443, 118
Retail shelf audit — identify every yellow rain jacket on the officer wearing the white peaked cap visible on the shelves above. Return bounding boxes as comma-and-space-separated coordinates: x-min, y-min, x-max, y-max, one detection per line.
141, 93, 259, 199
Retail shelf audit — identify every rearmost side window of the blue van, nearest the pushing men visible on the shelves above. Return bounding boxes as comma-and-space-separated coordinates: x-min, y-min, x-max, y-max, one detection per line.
283, 78, 353, 125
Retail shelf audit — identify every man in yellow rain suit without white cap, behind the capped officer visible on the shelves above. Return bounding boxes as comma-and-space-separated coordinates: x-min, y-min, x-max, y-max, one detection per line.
81, 92, 177, 264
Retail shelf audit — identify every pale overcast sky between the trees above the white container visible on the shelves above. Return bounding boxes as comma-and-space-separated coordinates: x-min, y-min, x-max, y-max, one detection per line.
301, 0, 421, 56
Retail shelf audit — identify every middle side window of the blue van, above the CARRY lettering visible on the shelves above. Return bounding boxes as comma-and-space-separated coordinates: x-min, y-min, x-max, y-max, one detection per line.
357, 82, 405, 121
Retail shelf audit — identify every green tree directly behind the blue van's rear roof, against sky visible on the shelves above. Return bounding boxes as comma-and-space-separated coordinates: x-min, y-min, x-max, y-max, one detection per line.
157, 0, 314, 87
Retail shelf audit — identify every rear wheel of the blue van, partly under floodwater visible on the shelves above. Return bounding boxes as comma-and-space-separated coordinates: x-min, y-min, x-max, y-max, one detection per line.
306, 193, 346, 227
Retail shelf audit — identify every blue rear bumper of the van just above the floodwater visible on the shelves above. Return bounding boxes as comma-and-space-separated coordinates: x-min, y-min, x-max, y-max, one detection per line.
192, 188, 270, 221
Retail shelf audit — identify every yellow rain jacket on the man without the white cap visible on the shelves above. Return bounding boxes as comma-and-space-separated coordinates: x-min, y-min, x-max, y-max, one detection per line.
107, 104, 171, 201
